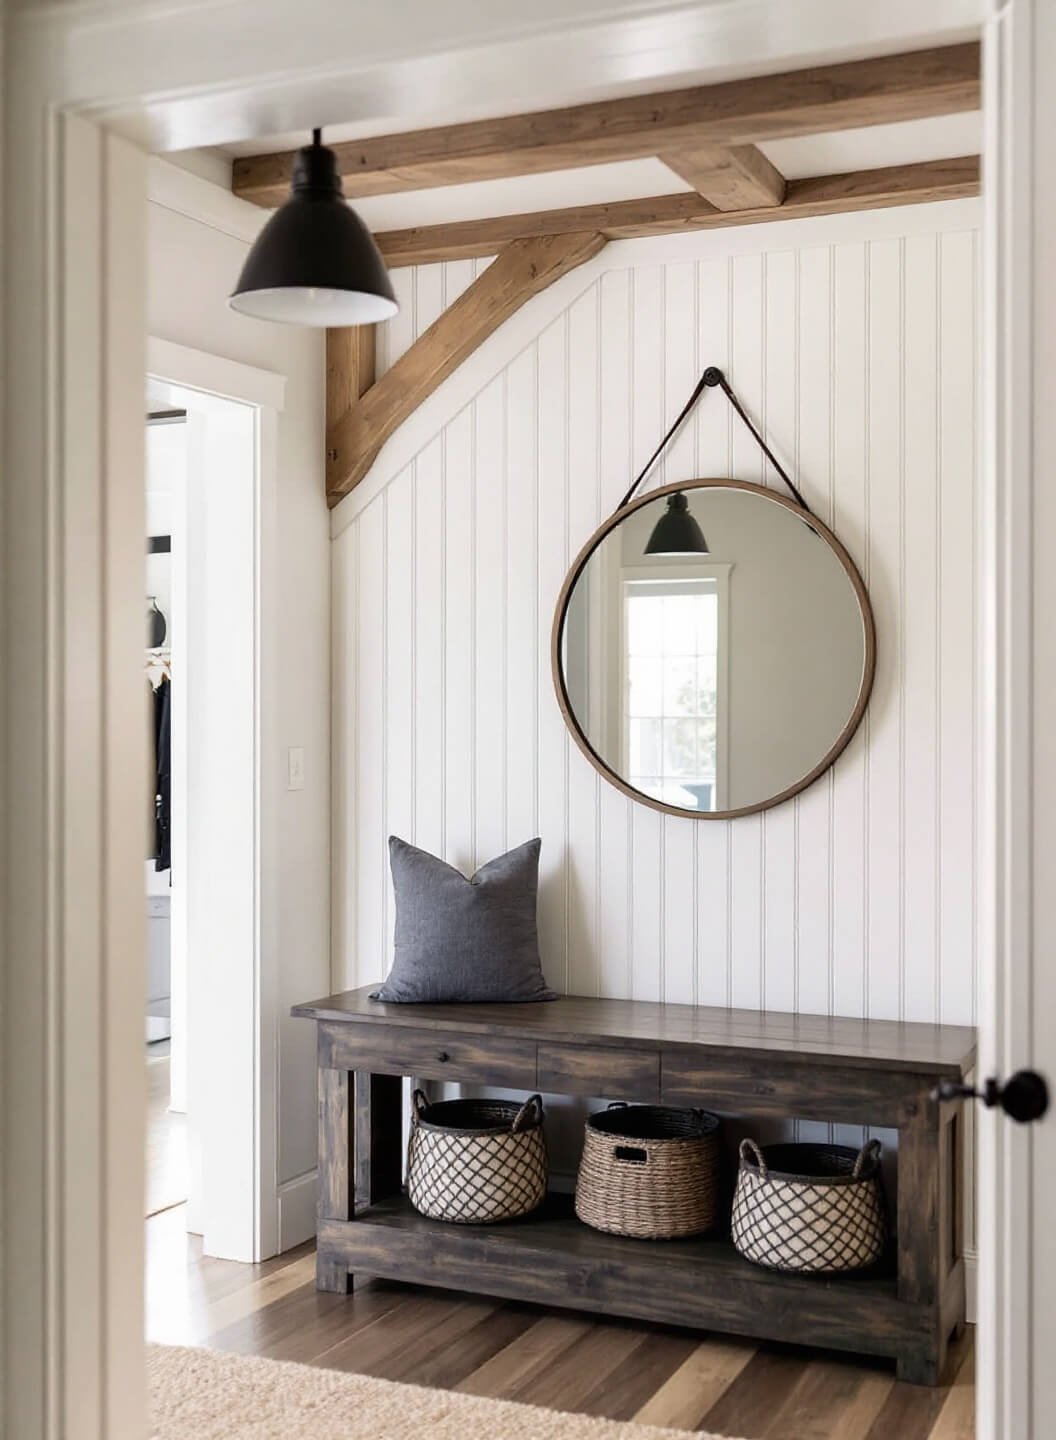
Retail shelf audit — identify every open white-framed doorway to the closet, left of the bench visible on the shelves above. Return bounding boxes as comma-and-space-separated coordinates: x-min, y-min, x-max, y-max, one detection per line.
146, 341, 282, 1260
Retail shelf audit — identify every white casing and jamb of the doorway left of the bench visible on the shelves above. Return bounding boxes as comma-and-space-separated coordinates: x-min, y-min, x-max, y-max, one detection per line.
147, 338, 285, 1261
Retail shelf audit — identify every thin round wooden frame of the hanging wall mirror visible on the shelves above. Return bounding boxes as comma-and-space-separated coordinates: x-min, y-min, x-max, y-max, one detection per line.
550, 480, 876, 819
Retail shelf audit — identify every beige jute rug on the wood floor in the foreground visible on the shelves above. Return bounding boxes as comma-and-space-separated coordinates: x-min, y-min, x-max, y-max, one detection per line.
147, 1345, 743, 1440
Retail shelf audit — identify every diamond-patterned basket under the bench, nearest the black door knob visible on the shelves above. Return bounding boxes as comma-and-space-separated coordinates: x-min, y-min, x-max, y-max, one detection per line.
732, 1140, 887, 1274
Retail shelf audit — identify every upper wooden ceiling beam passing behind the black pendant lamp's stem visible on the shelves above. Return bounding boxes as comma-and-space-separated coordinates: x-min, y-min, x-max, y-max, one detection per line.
232, 42, 980, 206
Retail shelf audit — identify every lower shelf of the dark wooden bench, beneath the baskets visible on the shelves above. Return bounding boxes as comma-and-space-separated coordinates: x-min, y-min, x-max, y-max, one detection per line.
318, 1195, 952, 1382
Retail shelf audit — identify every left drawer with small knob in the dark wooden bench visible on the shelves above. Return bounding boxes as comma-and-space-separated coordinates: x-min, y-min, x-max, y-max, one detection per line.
318, 1024, 536, 1089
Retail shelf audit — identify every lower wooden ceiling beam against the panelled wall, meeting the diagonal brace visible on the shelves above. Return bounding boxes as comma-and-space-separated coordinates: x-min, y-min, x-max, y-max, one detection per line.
375, 156, 980, 268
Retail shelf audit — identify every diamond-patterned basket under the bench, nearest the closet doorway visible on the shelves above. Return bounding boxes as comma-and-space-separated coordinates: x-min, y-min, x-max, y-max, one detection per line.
408, 1090, 547, 1225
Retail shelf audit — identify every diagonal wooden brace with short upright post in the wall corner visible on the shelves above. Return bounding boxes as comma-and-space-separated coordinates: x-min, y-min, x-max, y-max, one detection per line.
327, 232, 607, 510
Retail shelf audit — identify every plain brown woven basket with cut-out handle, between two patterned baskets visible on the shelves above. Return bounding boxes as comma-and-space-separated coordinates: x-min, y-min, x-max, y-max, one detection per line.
576, 1104, 720, 1240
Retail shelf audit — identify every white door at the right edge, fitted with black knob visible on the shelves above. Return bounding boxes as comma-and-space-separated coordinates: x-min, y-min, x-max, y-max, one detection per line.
978, 0, 1056, 1440
